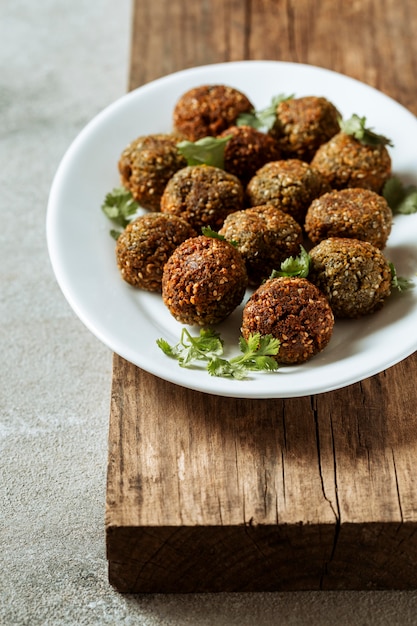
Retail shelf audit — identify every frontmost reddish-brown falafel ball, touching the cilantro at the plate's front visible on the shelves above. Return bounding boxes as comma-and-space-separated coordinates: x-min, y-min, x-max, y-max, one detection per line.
241, 277, 334, 365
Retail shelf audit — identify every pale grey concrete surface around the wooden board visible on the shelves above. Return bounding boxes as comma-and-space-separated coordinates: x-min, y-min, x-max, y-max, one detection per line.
0, 0, 417, 626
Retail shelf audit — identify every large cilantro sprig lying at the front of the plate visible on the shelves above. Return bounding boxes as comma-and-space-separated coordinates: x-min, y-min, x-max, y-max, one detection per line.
156, 328, 280, 380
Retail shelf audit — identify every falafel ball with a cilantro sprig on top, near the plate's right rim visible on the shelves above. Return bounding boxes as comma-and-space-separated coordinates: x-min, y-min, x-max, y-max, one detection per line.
311, 132, 391, 193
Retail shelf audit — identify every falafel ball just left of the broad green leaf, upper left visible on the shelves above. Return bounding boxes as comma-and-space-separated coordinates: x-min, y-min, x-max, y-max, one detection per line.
118, 133, 187, 211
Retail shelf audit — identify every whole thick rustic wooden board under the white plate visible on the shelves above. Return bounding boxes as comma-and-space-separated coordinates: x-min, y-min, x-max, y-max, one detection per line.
106, 0, 417, 592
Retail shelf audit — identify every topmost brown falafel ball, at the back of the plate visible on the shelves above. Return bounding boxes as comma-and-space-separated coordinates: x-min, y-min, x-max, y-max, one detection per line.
173, 85, 254, 141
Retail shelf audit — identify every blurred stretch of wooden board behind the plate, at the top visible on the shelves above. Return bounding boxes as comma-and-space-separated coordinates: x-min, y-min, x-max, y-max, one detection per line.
129, 0, 417, 114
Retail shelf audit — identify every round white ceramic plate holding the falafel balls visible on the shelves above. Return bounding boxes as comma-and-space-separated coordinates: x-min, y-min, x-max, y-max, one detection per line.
47, 61, 417, 398
